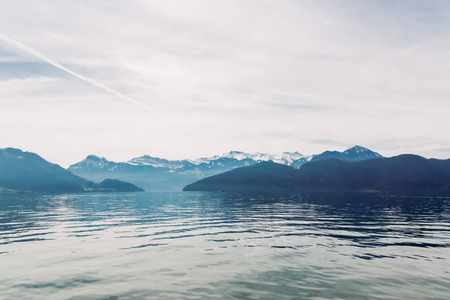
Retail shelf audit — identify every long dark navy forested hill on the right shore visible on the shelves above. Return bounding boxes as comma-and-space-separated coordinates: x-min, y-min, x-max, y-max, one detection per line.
183, 155, 450, 195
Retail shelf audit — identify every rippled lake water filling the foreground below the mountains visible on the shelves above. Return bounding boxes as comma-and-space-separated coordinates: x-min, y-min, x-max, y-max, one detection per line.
0, 193, 450, 299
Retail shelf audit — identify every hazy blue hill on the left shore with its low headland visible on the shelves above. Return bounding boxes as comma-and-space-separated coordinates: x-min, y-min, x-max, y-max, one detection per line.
0, 148, 142, 193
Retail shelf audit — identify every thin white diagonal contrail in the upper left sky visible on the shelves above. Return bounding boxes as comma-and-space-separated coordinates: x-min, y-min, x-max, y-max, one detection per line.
0, 33, 159, 115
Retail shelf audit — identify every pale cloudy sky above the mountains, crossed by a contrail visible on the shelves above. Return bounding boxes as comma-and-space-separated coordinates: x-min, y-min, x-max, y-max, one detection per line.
0, 0, 450, 167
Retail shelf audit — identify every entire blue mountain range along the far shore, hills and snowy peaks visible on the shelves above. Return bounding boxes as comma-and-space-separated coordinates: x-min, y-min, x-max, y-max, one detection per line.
4, 146, 450, 195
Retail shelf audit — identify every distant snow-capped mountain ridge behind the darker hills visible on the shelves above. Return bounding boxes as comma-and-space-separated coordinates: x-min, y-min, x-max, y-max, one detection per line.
68, 146, 382, 191
